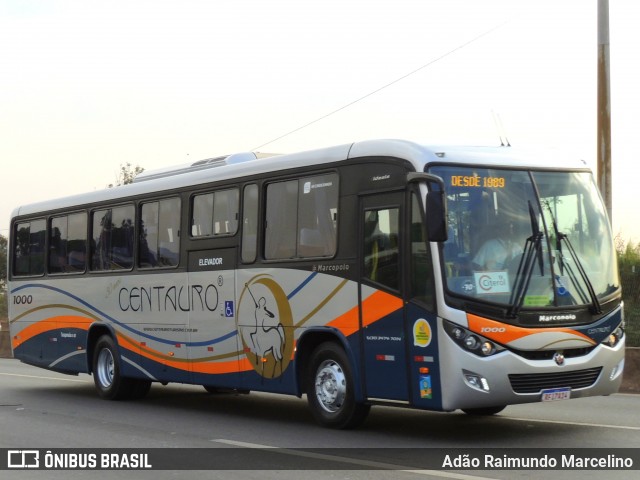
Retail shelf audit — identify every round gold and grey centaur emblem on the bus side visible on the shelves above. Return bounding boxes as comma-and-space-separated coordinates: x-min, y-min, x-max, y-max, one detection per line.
236, 275, 293, 378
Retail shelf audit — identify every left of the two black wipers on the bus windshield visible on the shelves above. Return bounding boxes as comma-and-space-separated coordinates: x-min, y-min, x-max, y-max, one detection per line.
507, 201, 544, 318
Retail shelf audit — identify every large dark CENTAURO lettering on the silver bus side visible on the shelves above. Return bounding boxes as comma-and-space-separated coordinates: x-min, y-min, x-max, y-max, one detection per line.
118, 284, 219, 312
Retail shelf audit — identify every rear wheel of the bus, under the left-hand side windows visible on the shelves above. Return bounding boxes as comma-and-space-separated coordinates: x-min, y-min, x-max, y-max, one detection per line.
93, 335, 151, 400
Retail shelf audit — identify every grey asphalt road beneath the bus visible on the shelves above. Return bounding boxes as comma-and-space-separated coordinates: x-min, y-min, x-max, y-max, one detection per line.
0, 359, 640, 480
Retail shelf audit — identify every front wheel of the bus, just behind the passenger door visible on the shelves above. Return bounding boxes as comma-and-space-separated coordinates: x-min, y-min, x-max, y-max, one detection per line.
307, 342, 371, 429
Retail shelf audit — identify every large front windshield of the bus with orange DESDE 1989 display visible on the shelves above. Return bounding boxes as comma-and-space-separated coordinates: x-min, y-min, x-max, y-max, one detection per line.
430, 166, 619, 315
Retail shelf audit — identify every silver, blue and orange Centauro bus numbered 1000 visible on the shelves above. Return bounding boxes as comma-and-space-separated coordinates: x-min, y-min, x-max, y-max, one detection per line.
8, 140, 625, 428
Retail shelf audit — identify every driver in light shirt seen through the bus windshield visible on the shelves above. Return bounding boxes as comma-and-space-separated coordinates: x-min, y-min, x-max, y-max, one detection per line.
472, 222, 522, 270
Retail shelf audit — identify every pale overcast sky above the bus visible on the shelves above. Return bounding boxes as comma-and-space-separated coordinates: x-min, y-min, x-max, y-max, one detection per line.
0, 0, 640, 242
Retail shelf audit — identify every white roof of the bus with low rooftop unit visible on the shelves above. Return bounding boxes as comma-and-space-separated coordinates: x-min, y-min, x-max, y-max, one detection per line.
11, 140, 587, 219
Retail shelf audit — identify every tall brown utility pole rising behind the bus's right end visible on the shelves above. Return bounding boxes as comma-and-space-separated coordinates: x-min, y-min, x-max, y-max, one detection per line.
597, 0, 613, 222
